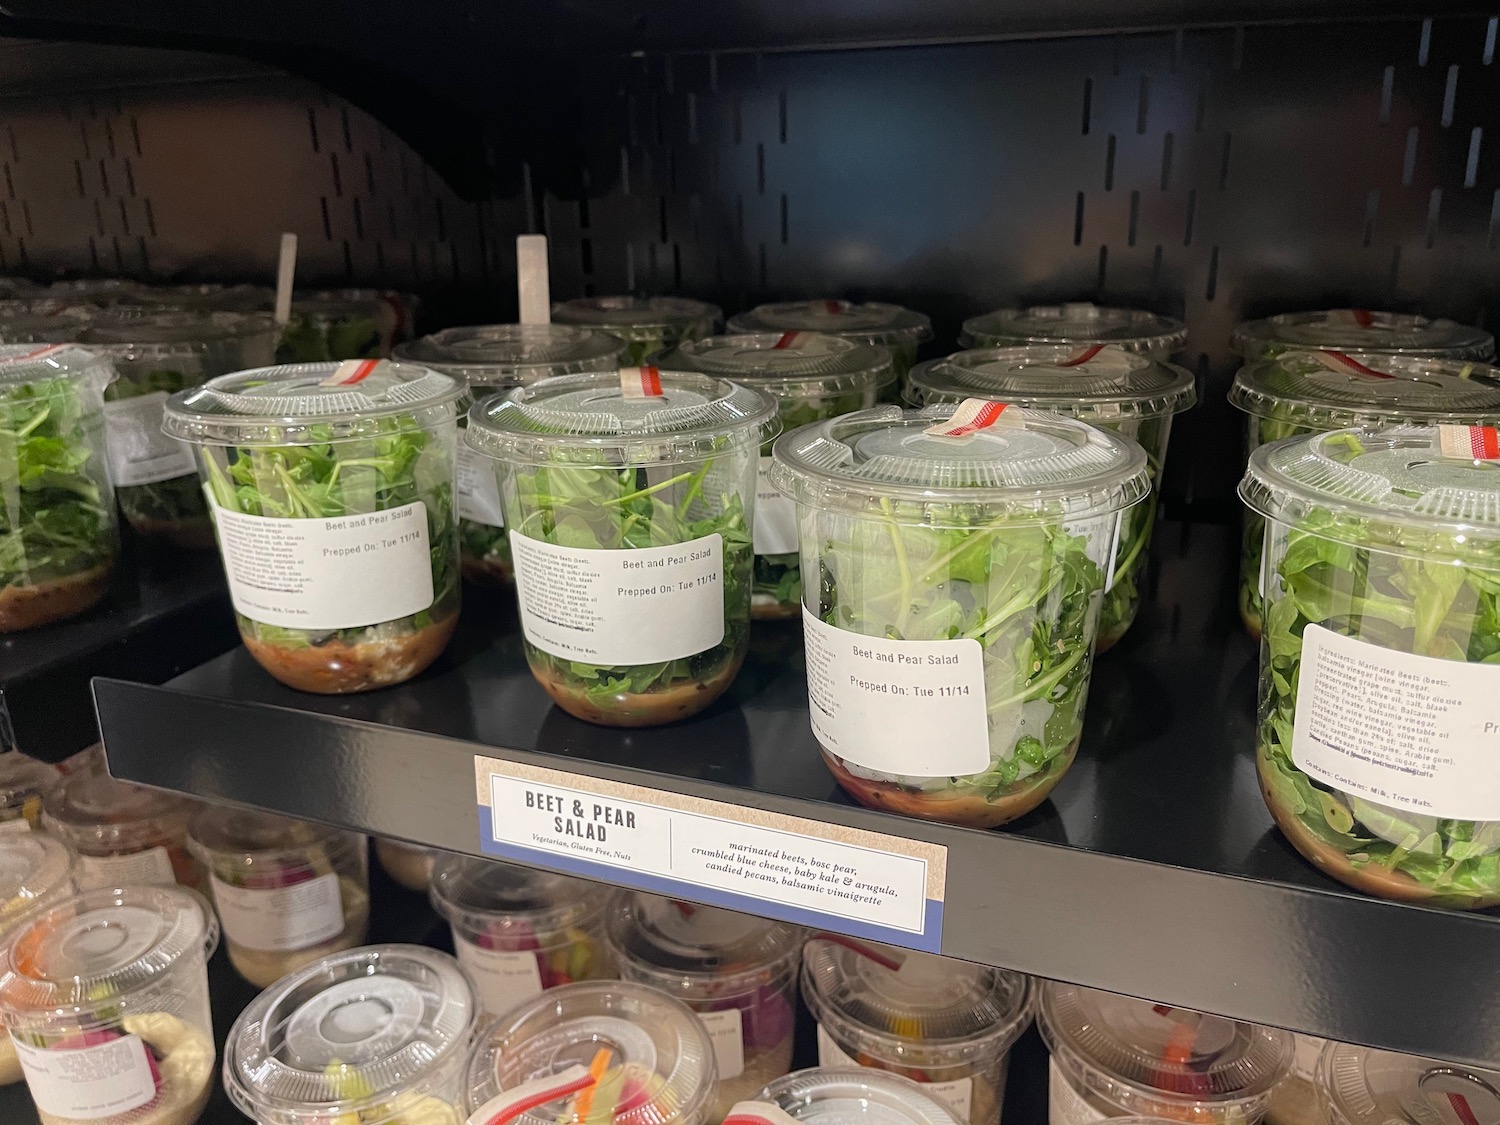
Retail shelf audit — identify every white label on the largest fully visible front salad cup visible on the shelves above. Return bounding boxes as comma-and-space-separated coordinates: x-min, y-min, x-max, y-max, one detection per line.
803, 606, 990, 777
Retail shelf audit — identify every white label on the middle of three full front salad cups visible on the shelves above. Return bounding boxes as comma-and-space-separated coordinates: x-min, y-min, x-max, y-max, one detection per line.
510, 531, 725, 665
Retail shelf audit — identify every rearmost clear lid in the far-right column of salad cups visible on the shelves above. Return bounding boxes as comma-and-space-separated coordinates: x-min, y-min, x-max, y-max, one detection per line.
1230, 309, 1496, 360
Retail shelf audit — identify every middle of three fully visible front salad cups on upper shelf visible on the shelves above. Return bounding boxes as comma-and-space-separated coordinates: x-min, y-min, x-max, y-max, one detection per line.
467, 368, 776, 726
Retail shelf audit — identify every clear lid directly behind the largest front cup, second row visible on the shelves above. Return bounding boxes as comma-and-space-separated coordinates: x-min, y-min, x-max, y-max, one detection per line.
909, 344, 1194, 422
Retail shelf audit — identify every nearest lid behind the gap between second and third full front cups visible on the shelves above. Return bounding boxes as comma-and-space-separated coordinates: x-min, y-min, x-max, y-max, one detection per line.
662, 332, 896, 399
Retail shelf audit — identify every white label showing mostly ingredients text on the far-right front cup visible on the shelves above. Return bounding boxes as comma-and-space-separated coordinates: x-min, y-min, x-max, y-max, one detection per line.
1292, 626, 1500, 821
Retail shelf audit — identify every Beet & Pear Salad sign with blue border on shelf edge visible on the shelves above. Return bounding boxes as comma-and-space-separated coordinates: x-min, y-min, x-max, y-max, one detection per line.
476, 758, 948, 950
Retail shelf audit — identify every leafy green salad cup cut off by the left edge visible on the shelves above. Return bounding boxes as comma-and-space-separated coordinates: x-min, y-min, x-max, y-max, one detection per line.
0, 344, 119, 633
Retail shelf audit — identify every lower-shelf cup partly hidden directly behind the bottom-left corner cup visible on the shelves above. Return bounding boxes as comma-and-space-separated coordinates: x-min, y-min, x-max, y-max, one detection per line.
42, 773, 204, 891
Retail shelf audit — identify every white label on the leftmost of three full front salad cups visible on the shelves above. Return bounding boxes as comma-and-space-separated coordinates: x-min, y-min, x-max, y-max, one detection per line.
215, 500, 432, 630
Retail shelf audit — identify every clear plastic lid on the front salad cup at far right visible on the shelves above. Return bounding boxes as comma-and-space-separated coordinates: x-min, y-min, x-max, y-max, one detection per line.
1239, 426, 1500, 551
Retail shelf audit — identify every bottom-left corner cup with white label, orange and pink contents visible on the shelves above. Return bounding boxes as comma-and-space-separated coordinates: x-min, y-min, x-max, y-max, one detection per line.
0, 887, 219, 1125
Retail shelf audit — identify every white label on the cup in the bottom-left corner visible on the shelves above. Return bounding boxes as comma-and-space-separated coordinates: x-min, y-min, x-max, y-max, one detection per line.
11, 1035, 156, 1121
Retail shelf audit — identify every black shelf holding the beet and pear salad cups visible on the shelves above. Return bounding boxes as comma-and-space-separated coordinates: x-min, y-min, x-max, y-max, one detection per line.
95, 522, 1500, 1065
